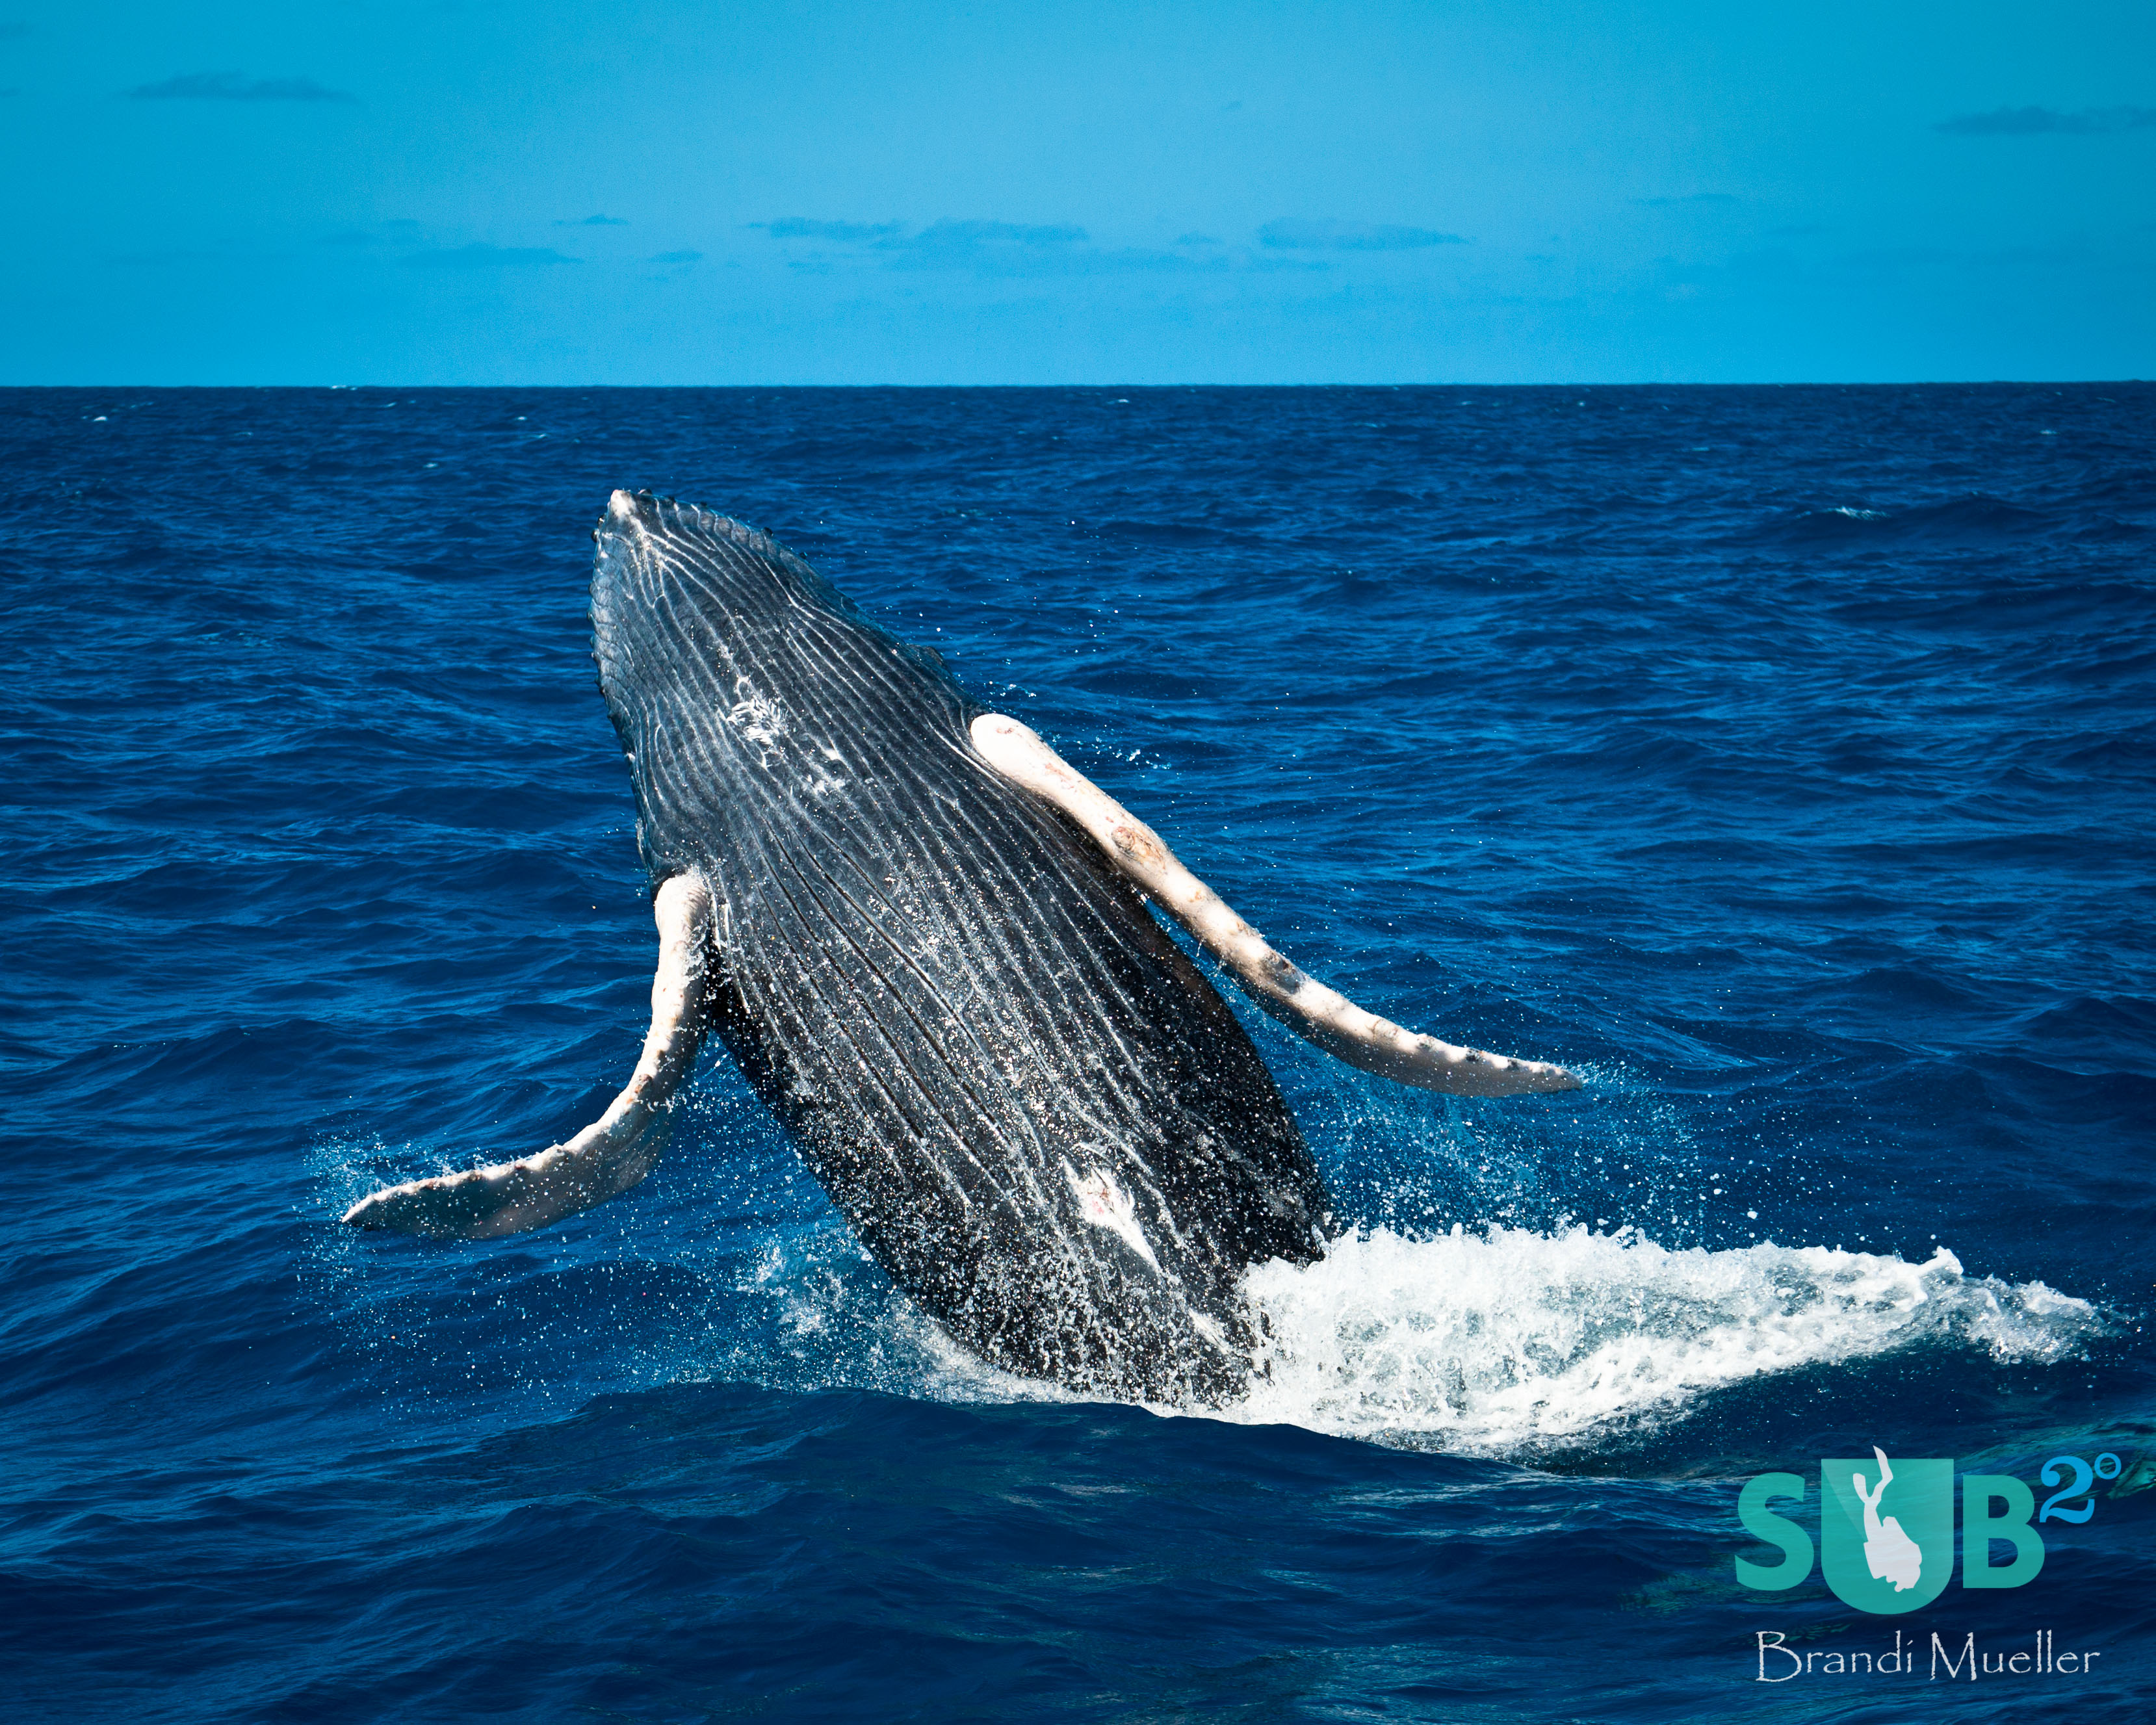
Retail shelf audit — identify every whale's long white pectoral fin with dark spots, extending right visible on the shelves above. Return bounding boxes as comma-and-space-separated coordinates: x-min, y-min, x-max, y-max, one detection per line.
972, 714, 1580, 1095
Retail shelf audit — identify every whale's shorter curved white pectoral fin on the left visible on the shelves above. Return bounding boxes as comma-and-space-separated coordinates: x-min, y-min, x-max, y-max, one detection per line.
345, 875, 712, 1240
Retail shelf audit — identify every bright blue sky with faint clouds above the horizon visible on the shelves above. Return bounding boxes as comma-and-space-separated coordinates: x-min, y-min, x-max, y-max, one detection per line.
0, 0, 2156, 384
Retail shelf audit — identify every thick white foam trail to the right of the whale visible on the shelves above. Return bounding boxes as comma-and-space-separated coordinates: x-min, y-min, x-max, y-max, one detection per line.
1227, 1227, 2100, 1453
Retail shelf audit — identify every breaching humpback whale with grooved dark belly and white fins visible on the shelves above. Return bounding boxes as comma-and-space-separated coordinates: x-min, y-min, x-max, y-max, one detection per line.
345, 491, 1578, 1401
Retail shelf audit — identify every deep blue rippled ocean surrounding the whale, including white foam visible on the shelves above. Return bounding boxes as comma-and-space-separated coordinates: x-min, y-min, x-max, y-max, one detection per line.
0, 384, 2156, 1725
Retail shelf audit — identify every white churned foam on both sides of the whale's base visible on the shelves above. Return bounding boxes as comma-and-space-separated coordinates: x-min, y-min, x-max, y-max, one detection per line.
720, 1225, 2107, 1460
